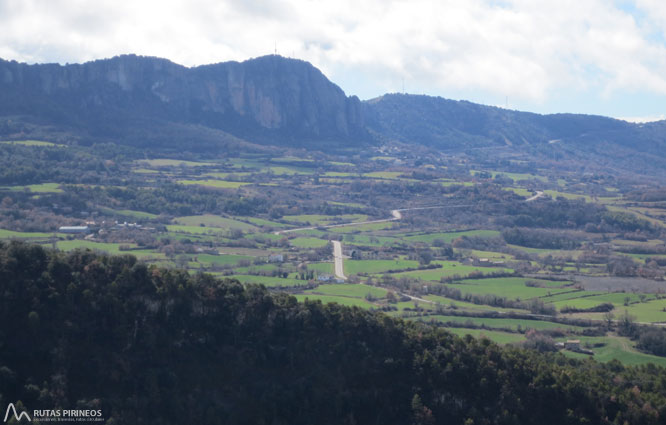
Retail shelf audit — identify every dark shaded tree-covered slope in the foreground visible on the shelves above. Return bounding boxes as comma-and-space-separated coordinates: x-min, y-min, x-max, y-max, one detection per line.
0, 242, 666, 424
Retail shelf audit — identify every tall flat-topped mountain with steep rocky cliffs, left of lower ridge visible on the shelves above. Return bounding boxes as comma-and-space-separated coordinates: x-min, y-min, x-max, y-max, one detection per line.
0, 55, 365, 141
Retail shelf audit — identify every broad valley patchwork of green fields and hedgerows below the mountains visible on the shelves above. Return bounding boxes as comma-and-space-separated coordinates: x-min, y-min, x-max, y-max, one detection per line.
0, 137, 666, 362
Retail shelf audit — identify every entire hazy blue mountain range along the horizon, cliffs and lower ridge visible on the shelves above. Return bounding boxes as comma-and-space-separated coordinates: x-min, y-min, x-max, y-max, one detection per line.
0, 55, 666, 174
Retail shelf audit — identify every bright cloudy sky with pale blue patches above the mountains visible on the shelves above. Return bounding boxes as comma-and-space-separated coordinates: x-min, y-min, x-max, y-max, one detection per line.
0, 0, 666, 121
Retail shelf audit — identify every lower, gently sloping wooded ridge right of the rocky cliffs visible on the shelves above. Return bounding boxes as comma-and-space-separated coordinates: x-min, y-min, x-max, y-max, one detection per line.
363, 94, 666, 176
